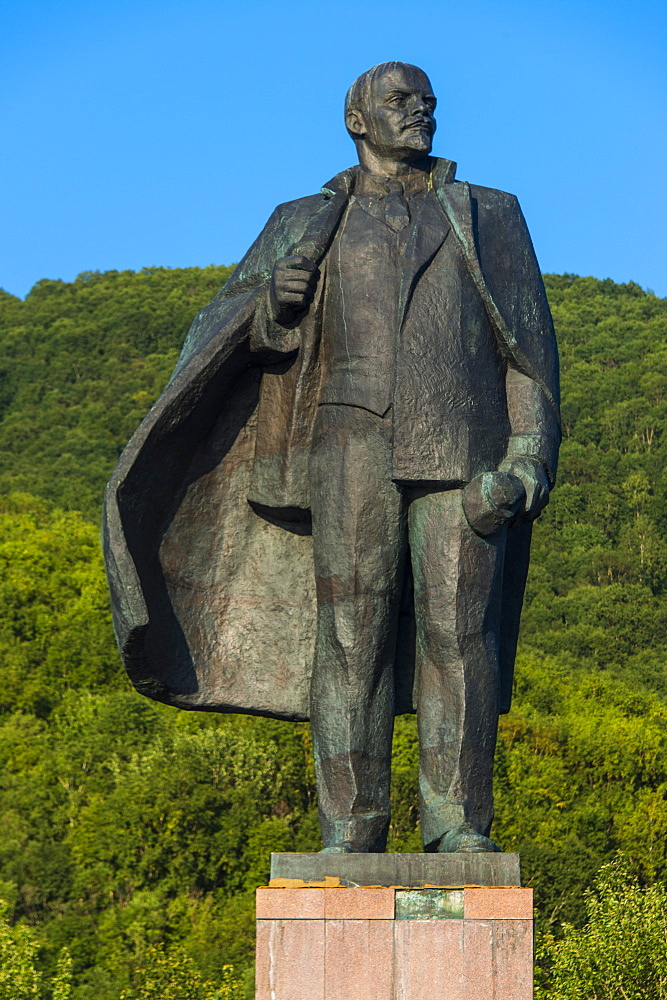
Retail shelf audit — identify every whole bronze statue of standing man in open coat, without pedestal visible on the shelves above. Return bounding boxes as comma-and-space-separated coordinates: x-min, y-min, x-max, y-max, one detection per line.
105, 63, 560, 852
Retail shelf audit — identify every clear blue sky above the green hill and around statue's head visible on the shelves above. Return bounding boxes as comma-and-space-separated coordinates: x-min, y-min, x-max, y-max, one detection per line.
0, 0, 667, 296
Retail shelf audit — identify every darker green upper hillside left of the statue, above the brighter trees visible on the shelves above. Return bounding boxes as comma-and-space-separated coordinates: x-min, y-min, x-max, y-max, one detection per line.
0, 266, 231, 520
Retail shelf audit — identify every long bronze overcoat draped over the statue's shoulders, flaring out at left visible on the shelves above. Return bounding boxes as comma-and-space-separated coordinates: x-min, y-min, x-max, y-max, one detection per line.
103, 160, 560, 719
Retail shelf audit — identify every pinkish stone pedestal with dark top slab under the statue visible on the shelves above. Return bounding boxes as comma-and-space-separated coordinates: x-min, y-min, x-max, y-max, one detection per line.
256, 855, 533, 1000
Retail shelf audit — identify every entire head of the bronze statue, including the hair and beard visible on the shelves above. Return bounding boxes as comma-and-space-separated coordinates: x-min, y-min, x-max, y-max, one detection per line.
345, 62, 436, 163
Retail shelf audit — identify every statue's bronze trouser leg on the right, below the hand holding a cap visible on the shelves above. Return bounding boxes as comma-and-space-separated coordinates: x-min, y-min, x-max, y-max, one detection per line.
409, 490, 506, 850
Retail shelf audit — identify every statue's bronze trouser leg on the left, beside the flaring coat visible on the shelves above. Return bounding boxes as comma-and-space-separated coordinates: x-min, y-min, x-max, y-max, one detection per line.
310, 406, 406, 851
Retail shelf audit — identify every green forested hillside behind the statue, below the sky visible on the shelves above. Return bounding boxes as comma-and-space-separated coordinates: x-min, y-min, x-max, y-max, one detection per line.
0, 267, 667, 1000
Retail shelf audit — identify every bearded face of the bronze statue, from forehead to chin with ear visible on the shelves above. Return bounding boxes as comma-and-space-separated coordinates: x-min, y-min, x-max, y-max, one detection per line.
347, 66, 436, 160
